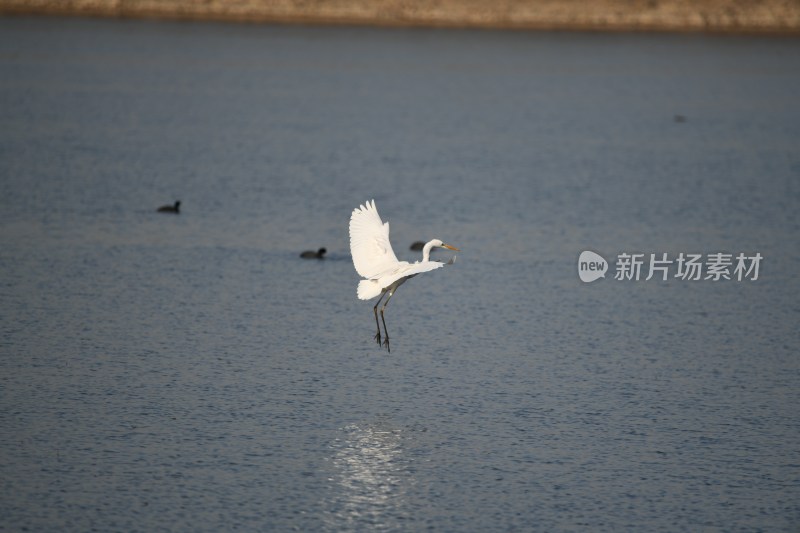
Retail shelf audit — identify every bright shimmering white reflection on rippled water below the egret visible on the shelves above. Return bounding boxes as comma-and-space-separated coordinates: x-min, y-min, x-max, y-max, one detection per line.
328, 421, 415, 529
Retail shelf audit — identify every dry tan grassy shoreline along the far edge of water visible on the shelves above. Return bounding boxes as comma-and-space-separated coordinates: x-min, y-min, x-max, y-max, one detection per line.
0, 0, 800, 35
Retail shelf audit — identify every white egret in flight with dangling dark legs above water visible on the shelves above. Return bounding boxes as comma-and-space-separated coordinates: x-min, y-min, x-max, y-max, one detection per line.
350, 200, 460, 352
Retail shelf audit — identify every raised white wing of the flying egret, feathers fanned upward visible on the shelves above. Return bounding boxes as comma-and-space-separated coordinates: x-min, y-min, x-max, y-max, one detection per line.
350, 200, 398, 278
